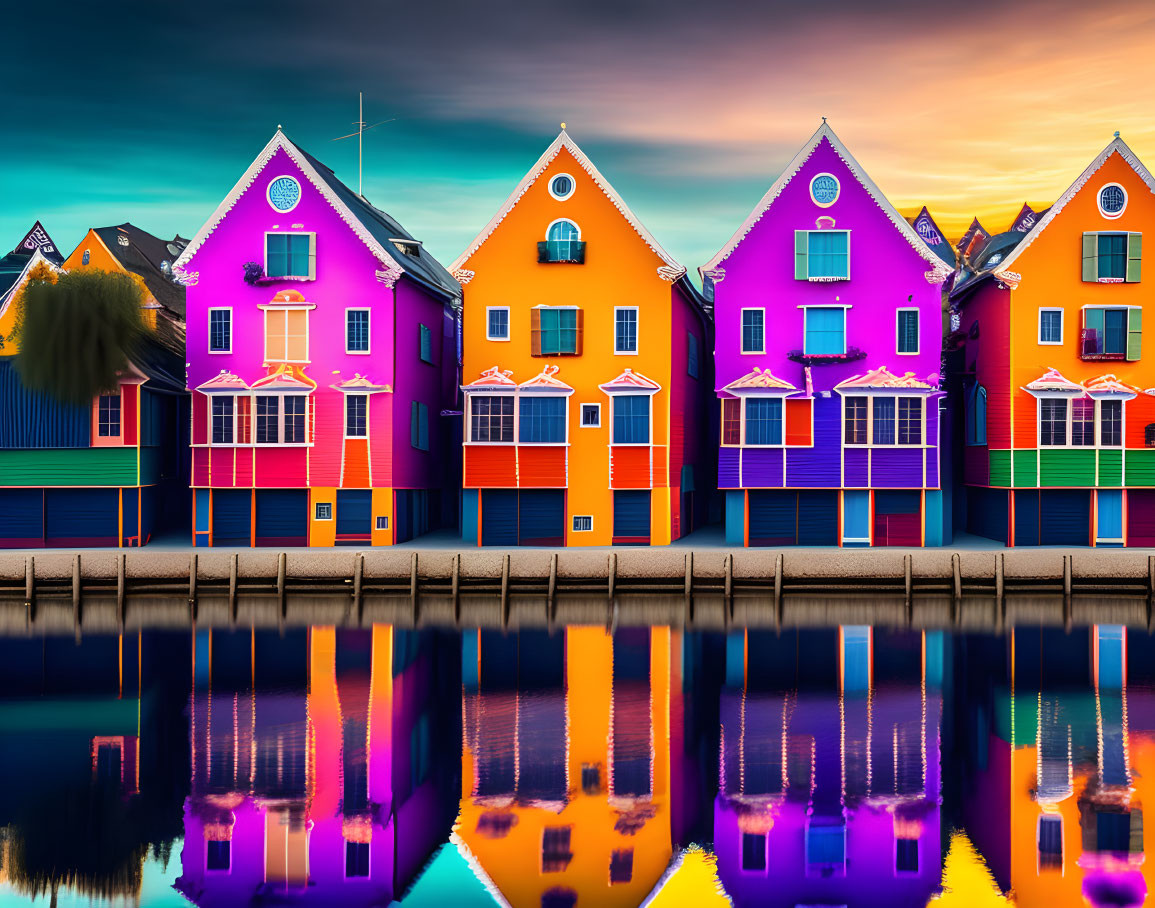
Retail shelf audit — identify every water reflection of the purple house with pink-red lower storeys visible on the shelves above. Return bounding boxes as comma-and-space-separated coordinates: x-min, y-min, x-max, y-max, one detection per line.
176, 625, 455, 906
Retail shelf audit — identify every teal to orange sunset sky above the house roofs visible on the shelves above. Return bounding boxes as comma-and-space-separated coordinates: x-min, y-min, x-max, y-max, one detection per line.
0, 0, 1155, 276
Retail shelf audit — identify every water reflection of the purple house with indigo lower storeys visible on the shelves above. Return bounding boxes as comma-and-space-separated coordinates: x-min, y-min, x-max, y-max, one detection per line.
714, 627, 944, 908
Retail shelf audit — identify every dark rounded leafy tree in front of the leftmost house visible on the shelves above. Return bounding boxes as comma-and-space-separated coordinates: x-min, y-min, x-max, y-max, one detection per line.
14, 270, 146, 404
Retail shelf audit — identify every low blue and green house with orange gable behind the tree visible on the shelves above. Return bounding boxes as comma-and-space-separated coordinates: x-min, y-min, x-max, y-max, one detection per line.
0, 224, 187, 549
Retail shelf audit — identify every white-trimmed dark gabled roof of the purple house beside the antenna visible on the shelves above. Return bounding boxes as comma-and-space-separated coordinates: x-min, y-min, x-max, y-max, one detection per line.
177, 129, 461, 298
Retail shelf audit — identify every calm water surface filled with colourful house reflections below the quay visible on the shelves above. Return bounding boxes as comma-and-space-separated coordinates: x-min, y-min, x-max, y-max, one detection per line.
0, 625, 1141, 908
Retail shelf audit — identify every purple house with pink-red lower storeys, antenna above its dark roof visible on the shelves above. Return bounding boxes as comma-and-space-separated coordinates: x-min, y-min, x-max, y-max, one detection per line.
174, 131, 460, 545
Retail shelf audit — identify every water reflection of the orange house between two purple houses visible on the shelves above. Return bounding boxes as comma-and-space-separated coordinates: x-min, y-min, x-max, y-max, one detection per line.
455, 627, 684, 908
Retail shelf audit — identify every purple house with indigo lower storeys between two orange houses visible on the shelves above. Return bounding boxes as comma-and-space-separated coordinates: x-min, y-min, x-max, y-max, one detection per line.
701, 122, 952, 545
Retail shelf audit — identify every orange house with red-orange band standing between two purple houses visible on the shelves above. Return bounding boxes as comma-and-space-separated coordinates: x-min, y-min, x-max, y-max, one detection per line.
453, 129, 713, 545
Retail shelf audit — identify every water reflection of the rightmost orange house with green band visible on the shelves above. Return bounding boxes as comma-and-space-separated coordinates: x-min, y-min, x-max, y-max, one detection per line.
964, 625, 1155, 908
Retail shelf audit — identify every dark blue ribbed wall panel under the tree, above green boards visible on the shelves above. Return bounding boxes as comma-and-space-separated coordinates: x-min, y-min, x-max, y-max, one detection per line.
0, 358, 92, 448
